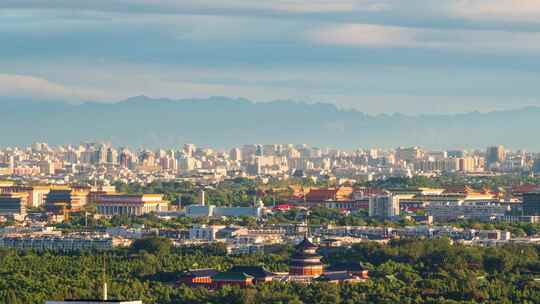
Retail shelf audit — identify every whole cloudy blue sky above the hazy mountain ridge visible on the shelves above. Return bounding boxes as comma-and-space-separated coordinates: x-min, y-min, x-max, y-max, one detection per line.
0, 0, 540, 114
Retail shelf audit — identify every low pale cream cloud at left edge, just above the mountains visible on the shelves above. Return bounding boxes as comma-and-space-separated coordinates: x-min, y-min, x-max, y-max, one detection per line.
0, 74, 108, 102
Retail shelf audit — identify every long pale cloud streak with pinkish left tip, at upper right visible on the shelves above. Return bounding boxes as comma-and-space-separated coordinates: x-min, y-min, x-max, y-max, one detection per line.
308, 24, 540, 53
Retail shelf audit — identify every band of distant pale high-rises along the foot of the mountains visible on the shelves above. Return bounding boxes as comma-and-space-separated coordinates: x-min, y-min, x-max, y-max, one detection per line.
0, 143, 540, 184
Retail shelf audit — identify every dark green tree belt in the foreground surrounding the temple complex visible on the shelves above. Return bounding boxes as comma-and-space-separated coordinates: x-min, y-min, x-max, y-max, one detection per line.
0, 239, 540, 304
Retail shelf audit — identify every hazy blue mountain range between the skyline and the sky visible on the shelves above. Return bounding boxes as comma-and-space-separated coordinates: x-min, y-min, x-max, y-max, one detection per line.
0, 96, 540, 151
